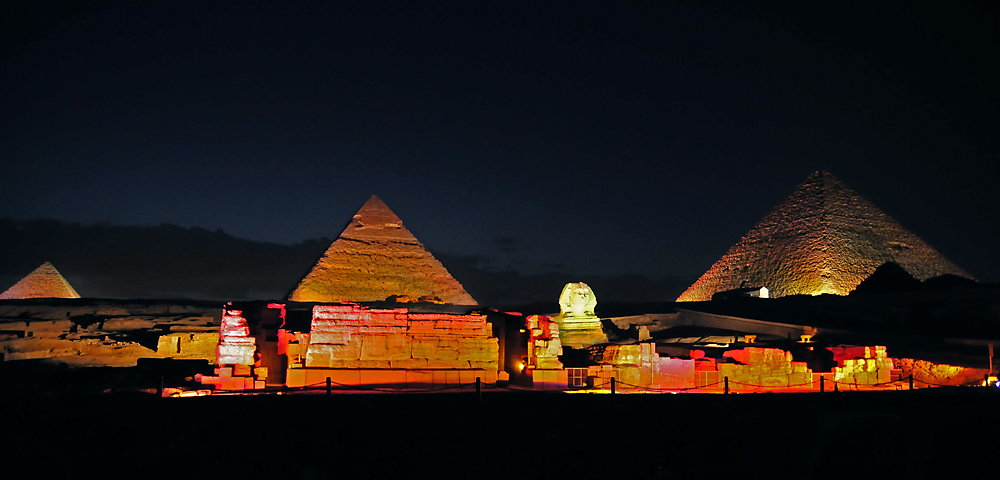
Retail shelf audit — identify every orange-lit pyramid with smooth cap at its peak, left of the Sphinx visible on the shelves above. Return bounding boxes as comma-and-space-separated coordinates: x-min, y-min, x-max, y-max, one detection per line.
288, 195, 476, 305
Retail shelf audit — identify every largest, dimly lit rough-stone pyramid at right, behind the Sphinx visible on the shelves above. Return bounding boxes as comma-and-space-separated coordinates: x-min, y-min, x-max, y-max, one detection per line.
677, 172, 972, 302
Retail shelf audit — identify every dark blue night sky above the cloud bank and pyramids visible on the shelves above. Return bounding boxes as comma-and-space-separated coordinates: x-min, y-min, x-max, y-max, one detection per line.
0, 1, 1000, 284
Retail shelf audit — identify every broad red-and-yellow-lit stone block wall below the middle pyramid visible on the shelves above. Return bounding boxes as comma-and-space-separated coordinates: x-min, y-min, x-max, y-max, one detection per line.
279, 304, 499, 386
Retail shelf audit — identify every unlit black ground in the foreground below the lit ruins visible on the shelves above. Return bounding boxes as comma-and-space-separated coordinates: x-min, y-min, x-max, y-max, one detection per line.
0, 376, 1000, 479
